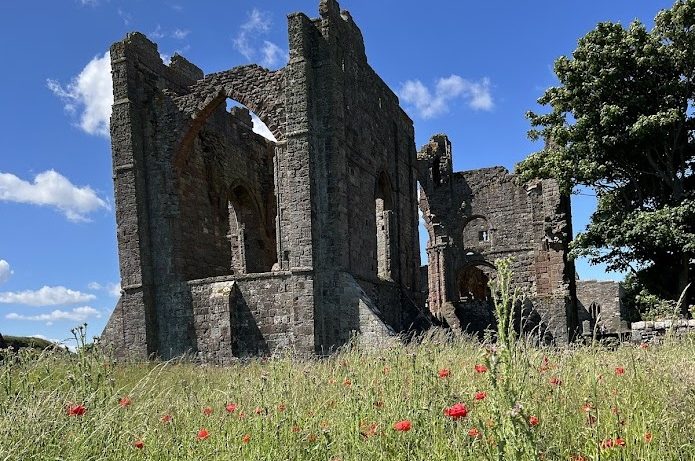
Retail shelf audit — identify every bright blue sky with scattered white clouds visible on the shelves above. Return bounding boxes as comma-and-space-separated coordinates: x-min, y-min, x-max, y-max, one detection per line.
0, 0, 671, 340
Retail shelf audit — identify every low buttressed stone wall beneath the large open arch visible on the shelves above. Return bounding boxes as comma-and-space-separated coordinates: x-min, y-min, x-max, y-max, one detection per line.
188, 270, 314, 364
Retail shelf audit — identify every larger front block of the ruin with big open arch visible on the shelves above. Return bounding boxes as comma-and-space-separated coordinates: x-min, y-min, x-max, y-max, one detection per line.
102, 0, 423, 363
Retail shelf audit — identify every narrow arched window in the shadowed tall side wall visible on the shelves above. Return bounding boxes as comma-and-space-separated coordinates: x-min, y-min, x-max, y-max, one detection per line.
374, 171, 395, 280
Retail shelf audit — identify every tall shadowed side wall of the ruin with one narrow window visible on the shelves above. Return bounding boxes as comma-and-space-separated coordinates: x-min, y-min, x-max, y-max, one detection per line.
290, 0, 419, 350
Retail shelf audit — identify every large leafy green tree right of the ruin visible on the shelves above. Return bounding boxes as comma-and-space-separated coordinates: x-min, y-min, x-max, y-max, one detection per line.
517, 0, 695, 310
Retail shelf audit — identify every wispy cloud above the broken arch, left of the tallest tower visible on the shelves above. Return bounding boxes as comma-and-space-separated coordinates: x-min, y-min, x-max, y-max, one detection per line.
234, 8, 289, 67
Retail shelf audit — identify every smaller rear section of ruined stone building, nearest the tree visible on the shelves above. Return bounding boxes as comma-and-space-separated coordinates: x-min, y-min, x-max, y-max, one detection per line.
418, 135, 577, 342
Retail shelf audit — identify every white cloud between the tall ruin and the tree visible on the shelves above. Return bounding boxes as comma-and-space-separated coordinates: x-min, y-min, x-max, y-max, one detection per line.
398, 75, 494, 119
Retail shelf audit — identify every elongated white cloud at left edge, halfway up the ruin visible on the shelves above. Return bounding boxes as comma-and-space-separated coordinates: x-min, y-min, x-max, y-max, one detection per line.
0, 170, 110, 221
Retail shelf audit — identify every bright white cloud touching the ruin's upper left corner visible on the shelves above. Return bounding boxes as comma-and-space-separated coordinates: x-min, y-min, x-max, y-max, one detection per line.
46, 51, 113, 137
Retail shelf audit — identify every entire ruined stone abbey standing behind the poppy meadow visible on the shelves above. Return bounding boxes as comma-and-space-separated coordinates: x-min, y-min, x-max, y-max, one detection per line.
102, 0, 621, 363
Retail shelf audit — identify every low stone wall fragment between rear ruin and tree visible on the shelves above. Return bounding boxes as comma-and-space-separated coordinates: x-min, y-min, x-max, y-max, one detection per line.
577, 280, 629, 335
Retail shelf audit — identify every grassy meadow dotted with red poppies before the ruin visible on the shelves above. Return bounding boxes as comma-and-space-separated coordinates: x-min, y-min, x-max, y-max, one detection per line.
0, 328, 695, 461
